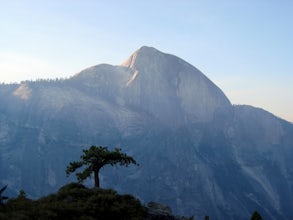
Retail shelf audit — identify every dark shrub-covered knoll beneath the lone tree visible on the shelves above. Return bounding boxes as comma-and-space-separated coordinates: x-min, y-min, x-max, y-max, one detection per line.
0, 183, 146, 220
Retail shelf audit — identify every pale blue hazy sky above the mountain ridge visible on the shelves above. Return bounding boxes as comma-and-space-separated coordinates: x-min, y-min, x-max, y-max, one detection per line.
0, 0, 293, 122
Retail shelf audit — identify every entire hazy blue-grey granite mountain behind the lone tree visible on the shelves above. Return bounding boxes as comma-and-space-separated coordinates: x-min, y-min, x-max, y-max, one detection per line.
0, 47, 293, 219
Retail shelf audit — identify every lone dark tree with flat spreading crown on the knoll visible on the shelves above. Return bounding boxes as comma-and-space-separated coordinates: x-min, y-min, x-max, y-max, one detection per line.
66, 146, 137, 187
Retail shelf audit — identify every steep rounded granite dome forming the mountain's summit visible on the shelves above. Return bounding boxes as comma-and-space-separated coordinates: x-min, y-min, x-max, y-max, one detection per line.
122, 47, 231, 126
